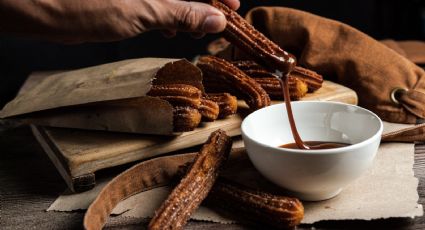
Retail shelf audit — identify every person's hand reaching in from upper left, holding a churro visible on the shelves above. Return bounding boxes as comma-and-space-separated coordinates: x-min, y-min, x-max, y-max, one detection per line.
0, 0, 240, 43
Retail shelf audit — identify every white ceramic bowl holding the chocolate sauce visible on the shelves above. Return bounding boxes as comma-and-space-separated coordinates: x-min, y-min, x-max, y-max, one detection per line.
242, 101, 383, 201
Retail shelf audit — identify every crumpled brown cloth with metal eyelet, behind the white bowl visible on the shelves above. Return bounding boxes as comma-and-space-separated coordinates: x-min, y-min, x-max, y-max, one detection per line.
224, 7, 425, 123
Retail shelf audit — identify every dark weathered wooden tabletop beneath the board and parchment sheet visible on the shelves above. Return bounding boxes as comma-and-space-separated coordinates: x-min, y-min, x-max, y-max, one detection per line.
0, 124, 425, 229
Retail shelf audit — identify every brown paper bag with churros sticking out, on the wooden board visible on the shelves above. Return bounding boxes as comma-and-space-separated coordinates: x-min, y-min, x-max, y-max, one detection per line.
0, 58, 204, 135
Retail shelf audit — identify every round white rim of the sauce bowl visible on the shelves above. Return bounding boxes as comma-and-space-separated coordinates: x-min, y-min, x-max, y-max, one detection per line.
241, 101, 384, 155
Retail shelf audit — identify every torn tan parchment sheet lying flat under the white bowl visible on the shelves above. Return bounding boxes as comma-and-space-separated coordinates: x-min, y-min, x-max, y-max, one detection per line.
47, 123, 423, 224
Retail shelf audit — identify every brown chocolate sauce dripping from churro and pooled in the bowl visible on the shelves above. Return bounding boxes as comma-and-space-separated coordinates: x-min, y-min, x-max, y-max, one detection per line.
278, 65, 349, 149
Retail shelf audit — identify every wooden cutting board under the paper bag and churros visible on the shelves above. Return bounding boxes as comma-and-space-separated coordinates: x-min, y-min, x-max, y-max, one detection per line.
28, 79, 357, 192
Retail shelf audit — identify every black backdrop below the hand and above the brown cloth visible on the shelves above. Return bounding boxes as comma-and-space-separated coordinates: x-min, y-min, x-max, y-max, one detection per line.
0, 0, 425, 108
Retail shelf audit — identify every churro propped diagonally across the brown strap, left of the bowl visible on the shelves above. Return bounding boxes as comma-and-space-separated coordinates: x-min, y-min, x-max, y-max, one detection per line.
148, 130, 232, 230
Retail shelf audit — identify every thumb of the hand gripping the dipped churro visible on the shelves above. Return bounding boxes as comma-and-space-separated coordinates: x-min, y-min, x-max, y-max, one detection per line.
159, 1, 226, 33
